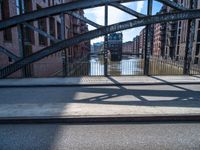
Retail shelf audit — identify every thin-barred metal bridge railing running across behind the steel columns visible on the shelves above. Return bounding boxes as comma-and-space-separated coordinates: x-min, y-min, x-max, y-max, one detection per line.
0, 58, 200, 78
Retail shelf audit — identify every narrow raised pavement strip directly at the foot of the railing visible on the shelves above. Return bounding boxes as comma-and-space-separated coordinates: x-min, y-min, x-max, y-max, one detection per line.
0, 75, 200, 87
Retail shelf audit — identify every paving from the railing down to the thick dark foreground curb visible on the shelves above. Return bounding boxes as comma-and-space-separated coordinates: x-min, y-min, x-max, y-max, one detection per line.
0, 76, 200, 118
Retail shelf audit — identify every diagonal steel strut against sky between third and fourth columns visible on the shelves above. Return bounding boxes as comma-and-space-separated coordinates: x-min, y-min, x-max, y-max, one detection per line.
109, 3, 146, 18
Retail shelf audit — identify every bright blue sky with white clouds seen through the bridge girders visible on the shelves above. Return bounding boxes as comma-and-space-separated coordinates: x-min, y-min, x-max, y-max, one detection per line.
84, 1, 162, 44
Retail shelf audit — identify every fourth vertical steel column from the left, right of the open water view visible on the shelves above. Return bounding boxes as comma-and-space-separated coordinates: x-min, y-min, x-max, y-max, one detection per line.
144, 0, 153, 75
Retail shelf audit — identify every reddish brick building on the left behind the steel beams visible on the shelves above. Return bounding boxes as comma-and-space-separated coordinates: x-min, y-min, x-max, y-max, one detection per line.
0, 0, 90, 77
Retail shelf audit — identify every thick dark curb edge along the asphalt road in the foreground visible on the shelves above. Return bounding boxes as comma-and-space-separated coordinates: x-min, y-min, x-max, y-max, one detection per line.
0, 115, 200, 124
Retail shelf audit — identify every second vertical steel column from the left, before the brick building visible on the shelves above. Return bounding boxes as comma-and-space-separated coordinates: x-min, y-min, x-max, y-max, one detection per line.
60, 13, 67, 77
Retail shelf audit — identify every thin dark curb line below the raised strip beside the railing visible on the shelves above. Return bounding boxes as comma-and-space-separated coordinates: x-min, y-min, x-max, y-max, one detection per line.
0, 82, 200, 88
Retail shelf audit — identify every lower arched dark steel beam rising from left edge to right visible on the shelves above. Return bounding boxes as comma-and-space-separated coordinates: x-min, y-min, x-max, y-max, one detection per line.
0, 9, 200, 78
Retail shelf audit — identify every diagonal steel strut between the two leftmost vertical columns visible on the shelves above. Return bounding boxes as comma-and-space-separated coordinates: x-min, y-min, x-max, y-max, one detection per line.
23, 22, 60, 42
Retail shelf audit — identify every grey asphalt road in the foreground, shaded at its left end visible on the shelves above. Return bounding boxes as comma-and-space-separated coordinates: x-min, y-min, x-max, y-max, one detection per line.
0, 123, 200, 150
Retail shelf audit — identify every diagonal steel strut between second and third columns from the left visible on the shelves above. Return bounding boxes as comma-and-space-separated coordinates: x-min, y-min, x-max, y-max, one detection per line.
67, 11, 102, 28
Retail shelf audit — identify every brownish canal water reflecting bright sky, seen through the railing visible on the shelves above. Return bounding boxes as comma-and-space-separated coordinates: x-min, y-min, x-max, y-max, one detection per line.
90, 55, 143, 76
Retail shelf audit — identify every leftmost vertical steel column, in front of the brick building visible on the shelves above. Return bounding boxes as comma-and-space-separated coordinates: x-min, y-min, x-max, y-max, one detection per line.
17, 0, 27, 77
